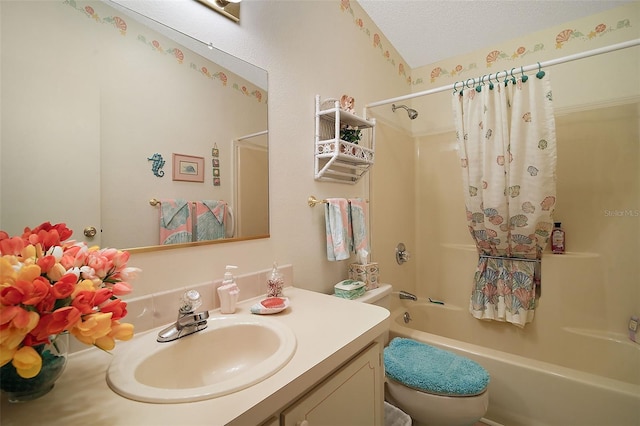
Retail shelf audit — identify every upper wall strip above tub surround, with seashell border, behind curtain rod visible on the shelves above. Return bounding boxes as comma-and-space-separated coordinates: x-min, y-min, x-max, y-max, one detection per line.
411, 2, 640, 135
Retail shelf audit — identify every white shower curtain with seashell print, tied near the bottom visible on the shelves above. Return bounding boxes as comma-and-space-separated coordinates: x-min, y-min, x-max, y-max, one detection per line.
453, 76, 556, 327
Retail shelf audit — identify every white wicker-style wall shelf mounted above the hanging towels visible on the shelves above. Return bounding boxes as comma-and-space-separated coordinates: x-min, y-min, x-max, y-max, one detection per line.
315, 95, 376, 184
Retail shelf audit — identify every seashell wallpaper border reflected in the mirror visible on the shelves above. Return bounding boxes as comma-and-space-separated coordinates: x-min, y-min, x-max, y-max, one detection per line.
64, 0, 267, 103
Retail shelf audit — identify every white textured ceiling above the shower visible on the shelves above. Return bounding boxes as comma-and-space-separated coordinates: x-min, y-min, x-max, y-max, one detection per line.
357, 0, 637, 68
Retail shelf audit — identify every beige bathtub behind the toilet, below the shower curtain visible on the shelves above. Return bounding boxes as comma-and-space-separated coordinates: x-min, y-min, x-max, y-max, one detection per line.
389, 293, 640, 426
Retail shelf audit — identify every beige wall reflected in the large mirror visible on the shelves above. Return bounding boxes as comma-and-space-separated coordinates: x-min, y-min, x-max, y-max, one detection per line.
0, 1, 267, 248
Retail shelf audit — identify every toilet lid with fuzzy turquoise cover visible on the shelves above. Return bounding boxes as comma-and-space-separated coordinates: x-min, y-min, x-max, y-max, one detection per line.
384, 337, 489, 396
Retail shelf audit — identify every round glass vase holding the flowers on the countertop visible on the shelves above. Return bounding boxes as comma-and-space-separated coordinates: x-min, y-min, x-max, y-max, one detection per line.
0, 333, 69, 402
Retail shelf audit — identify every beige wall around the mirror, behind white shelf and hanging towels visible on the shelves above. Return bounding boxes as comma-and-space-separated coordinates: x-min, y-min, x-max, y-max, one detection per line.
107, 0, 409, 295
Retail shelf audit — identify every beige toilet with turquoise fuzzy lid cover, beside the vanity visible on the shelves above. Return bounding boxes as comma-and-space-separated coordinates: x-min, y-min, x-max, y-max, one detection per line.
354, 284, 489, 426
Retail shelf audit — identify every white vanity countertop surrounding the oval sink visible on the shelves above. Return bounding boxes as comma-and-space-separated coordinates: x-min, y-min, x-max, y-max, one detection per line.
0, 287, 389, 426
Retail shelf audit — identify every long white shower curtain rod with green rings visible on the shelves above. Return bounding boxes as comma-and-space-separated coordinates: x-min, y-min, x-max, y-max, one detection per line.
364, 39, 640, 109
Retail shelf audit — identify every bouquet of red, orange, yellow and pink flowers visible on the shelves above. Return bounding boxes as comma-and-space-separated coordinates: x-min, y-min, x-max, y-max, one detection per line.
0, 222, 140, 378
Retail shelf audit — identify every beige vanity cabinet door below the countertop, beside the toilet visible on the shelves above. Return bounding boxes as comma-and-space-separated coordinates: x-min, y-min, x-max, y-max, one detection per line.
280, 342, 384, 426
